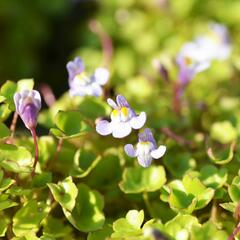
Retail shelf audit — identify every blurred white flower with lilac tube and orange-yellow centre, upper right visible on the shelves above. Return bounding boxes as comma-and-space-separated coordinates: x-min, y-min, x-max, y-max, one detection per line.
176, 43, 211, 86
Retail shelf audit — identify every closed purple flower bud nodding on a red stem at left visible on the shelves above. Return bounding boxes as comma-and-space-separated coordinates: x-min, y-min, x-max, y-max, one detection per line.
14, 90, 41, 130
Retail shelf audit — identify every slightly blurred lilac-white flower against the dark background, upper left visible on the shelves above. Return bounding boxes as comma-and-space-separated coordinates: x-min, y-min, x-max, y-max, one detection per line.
67, 57, 109, 97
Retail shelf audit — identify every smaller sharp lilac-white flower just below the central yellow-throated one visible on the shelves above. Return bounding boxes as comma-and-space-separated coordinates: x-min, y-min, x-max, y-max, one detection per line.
124, 128, 166, 168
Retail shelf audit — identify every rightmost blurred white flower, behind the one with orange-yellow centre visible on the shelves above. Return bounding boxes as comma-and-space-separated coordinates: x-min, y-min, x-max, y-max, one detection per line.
195, 23, 232, 60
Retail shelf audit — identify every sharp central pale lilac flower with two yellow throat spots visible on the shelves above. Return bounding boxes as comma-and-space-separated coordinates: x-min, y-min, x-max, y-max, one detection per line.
96, 95, 146, 138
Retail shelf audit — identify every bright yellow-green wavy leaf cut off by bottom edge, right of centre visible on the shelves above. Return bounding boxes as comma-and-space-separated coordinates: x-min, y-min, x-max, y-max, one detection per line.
164, 214, 200, 240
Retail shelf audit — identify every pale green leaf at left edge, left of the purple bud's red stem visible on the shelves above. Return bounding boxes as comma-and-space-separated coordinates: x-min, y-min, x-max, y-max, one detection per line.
0, 144, 33, 173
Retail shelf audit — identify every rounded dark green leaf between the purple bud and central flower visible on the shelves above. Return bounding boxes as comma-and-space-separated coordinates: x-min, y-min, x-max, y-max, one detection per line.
50, 111, 91, 139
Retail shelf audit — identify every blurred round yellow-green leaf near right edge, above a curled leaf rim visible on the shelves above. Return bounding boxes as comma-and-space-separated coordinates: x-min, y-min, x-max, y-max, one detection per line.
210, 121, 237, 144
